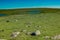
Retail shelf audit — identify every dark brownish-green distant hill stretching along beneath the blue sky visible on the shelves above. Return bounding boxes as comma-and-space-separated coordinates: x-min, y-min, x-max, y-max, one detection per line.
0, 8, 60, 15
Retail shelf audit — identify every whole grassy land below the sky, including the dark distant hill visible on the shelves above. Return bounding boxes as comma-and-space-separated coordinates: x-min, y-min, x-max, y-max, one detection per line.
0, 8, 60, 40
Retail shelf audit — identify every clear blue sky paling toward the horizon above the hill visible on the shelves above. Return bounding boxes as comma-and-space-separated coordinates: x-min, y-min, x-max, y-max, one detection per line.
0, 0, 60, 9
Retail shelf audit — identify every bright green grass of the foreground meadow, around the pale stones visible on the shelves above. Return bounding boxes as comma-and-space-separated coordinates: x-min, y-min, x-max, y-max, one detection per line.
0, 13, 60, 40
